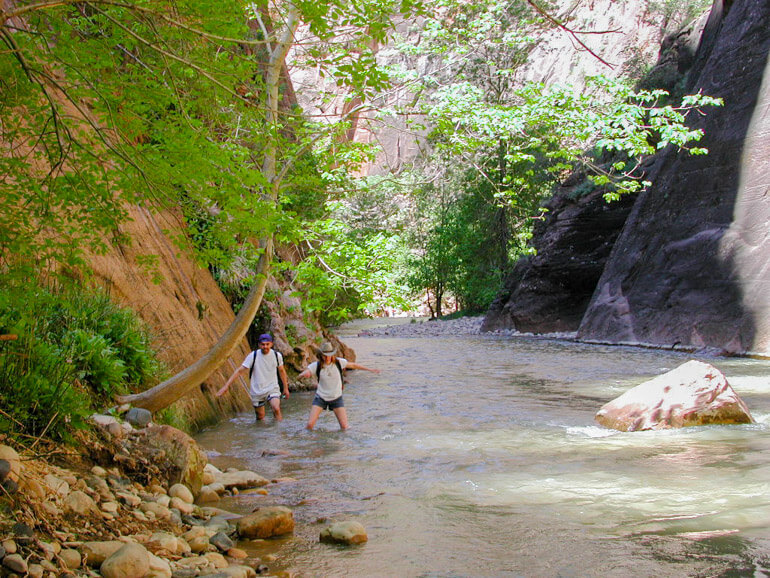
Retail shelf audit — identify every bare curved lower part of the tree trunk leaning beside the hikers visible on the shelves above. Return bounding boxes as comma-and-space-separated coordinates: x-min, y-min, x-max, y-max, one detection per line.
112, 238, 273, 412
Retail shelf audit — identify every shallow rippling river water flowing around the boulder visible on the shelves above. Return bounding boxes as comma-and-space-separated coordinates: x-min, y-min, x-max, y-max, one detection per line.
198, 326, 770, 577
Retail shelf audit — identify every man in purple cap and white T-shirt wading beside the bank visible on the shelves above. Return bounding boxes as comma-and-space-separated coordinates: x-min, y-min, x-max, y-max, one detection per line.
217, 333, 289, 421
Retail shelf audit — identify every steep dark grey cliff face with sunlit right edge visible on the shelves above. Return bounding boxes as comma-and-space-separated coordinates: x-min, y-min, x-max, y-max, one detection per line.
578, 0, 770, 355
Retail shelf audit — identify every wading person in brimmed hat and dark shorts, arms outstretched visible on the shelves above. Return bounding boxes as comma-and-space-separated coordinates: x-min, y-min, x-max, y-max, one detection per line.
297, 341, 380, 430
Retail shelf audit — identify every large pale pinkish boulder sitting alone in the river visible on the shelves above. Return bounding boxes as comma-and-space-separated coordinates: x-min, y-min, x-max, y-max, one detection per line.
596, 360, 754, 431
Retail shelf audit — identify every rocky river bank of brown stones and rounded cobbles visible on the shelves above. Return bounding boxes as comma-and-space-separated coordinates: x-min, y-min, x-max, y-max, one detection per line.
0, 416, 294, 578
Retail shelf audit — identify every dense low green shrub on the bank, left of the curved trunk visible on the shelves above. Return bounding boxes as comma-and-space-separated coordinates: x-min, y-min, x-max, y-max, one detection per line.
0, 275, 166, 440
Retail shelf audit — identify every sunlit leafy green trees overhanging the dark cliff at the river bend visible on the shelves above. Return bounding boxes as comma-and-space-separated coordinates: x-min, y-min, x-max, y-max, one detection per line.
384, 0, 719, 315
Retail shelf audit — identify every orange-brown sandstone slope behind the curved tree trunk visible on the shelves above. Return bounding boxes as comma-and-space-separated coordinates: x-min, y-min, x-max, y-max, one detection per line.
89, 207, 249, 426
